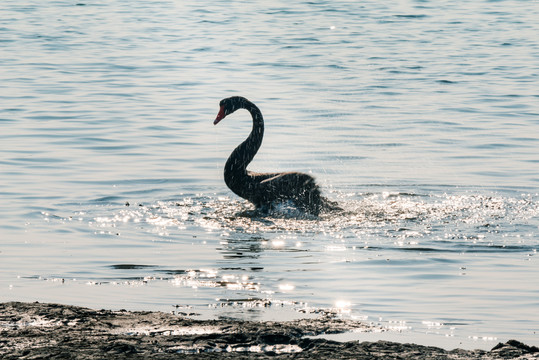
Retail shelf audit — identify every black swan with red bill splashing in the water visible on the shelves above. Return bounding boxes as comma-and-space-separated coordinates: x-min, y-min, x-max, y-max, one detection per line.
213, 96, 334, 216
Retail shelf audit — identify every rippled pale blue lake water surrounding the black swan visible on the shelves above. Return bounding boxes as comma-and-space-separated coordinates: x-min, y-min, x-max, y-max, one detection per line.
0, 0, 539, 348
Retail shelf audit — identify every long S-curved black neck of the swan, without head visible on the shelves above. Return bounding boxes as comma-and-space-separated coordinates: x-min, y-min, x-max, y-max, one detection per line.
224, 100, 264, 196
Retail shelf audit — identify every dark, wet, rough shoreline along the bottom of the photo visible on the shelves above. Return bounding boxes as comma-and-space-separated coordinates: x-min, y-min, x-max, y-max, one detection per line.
0, 302, 539, 359
